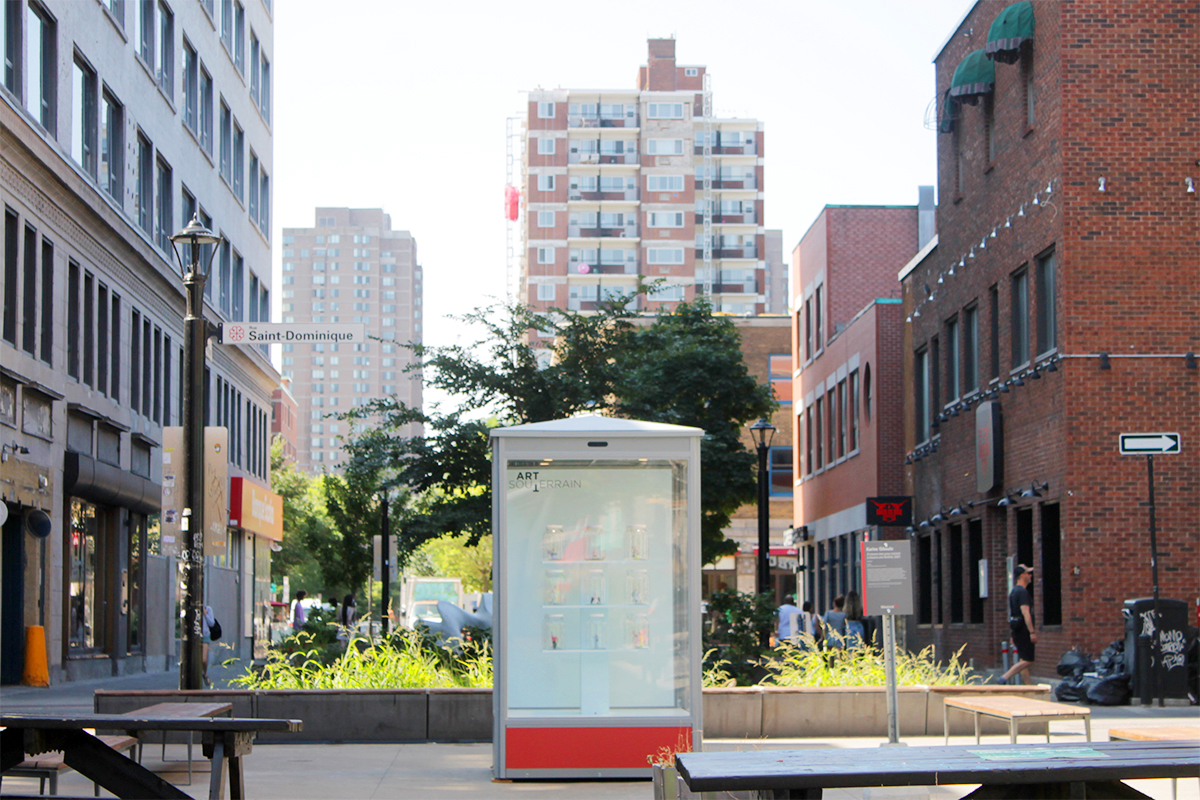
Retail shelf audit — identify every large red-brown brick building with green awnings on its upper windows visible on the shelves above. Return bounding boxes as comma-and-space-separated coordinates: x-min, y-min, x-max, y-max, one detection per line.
900, 0, 1200, 674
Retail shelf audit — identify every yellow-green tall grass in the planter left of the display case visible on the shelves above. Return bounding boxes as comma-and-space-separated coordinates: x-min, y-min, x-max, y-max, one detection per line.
229, 631, 492, 688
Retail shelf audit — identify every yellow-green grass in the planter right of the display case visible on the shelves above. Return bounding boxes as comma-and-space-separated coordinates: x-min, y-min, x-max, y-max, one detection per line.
763, 631, 982, 686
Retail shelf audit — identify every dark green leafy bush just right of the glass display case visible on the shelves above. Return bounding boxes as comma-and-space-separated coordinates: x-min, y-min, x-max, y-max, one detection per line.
703, 589, 775, 686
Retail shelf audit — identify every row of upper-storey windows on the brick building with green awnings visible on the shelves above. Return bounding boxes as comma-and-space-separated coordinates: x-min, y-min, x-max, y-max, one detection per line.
913, 251, 1058, 443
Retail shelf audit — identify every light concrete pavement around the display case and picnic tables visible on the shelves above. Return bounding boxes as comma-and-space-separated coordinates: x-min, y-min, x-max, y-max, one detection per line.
0, 667, 1200, 800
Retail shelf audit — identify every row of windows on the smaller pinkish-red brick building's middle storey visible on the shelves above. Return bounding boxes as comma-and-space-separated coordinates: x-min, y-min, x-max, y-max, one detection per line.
797, 367, 871, 476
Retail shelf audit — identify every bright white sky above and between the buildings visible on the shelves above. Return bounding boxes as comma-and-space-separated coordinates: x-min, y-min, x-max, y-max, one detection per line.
274, 0, 971, 386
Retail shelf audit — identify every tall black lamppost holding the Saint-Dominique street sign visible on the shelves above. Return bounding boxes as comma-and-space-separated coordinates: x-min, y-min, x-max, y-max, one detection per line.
170, 215, 221, 690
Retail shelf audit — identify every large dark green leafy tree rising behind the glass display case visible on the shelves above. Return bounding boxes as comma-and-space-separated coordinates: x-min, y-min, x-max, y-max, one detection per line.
343, 297, 774, 564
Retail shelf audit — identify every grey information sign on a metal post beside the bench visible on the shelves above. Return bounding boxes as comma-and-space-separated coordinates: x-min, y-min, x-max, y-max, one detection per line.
863, 540, 913, 745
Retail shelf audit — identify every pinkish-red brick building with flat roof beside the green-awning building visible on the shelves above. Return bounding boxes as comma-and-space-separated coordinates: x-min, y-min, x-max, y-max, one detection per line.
791, 196, 934, 610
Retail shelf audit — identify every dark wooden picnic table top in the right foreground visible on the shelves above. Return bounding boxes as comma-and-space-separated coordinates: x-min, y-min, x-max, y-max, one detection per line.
676, 741, 1200, 799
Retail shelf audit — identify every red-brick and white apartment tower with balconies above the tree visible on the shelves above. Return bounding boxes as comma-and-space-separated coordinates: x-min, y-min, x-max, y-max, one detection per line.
518, 38, 768, 314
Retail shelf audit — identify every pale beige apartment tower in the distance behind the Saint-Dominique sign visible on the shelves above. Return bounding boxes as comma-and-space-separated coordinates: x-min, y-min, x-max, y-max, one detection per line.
282, 209, 421, 473
